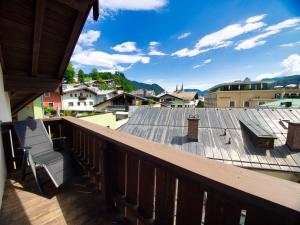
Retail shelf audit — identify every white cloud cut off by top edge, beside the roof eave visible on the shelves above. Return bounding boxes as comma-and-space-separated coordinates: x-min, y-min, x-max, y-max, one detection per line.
100, 0, 167, 11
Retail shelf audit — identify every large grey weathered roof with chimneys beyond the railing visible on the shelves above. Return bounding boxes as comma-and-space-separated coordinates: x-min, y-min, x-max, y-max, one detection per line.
119, 107, 300, 172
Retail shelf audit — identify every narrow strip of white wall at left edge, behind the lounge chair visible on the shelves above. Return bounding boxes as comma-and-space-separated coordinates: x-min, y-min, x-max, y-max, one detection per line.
0, 62, 11, 208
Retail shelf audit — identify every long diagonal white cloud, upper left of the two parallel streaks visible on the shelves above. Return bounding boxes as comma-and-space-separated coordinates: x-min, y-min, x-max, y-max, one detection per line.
171, 14, 266, 57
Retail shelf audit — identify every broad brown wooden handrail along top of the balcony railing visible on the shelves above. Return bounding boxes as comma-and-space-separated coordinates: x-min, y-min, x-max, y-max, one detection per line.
63, 117, 300, 218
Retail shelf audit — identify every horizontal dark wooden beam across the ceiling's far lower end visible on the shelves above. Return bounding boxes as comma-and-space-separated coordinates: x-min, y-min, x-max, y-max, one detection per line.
4, 74, 61, 93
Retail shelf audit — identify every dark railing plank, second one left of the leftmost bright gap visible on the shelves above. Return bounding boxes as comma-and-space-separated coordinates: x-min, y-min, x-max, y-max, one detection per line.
139, 161, 155, 219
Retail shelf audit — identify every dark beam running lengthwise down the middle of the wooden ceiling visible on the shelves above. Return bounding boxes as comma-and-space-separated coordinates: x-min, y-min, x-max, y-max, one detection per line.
31, 0, 47, 76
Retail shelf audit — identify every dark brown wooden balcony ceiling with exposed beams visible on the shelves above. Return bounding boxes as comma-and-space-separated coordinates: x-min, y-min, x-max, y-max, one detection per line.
0, 0, 99, 114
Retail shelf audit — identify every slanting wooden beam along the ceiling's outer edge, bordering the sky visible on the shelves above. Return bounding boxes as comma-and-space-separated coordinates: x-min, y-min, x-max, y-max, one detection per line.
57, 5, 91, 79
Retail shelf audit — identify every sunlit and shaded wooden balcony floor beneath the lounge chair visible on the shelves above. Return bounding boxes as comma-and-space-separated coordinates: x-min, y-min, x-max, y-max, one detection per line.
0, 173, 118, 225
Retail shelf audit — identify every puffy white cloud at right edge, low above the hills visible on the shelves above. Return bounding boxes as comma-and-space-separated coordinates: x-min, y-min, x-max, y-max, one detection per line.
255, 54, 300, 80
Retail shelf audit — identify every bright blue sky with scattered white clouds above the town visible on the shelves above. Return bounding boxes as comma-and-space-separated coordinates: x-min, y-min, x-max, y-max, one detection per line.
71, 0, 300, 91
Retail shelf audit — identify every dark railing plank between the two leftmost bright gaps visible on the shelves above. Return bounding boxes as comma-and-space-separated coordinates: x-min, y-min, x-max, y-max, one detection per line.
176, 179, 204, 225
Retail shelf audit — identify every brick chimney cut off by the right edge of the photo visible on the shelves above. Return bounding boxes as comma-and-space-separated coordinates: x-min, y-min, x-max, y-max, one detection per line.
286, 122, 300, 151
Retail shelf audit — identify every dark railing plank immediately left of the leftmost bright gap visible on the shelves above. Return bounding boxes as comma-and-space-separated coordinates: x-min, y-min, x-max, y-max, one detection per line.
155, 168, 175, 225
